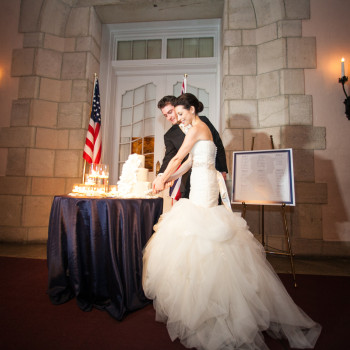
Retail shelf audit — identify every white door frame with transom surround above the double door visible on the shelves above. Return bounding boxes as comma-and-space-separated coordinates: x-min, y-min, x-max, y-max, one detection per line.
100, 19, 221, 183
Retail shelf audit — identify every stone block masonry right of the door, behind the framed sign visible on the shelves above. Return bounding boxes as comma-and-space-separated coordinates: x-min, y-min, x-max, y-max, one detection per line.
221, 0, 342, 254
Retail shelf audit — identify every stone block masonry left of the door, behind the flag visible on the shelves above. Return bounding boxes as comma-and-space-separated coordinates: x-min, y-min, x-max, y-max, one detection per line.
0, 0, 101, 242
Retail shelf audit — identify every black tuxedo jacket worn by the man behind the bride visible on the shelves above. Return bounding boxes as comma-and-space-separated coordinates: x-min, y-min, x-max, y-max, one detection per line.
159, 116, 228, 198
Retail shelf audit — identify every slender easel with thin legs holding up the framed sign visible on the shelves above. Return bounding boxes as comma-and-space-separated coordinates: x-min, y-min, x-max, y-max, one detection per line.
241, 135, 297, 287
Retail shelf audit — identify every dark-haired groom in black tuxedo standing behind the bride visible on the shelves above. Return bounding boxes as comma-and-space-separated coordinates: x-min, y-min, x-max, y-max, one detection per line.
152, 96, 228, 198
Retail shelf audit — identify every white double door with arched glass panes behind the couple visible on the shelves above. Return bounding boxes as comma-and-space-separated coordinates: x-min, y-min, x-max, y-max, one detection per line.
105, 73, 219, 189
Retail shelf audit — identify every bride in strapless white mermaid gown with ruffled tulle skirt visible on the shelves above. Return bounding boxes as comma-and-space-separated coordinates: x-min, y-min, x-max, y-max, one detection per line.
143, 93, 321, 350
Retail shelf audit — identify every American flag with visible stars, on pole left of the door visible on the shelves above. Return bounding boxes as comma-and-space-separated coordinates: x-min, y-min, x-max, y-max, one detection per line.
83, 78, 102, 164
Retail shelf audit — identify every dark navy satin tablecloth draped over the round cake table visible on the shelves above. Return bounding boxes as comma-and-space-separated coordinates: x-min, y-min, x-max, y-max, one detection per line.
47, 196, 163, 320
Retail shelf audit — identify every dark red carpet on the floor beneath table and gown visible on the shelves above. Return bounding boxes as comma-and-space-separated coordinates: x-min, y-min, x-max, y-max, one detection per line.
0, 257, 350, 350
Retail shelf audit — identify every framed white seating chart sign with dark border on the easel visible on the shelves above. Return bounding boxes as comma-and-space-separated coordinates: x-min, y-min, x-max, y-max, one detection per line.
231, 149, 295, 206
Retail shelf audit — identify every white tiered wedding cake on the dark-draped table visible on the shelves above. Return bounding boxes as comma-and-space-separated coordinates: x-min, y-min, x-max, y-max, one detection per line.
117, 153, 151, 198
